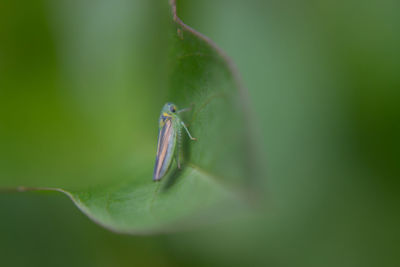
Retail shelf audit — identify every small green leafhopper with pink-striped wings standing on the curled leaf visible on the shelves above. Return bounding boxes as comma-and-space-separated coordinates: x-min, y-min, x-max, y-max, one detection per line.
153, 103, 197, 181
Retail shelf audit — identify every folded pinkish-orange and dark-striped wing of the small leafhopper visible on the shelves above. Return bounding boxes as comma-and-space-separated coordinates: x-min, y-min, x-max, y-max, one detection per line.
153, 117, 176, 181
